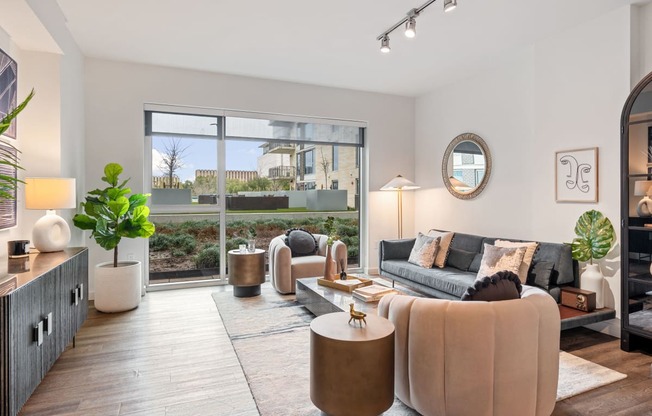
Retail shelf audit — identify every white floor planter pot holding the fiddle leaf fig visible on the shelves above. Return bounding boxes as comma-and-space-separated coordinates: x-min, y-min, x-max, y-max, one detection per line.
95, 261, 142, 312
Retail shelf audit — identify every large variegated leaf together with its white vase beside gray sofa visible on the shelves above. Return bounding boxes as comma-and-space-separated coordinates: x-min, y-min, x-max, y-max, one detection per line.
570, 210, 616, 309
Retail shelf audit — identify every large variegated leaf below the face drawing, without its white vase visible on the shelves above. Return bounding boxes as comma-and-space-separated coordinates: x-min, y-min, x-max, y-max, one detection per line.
570, 210, 616, 264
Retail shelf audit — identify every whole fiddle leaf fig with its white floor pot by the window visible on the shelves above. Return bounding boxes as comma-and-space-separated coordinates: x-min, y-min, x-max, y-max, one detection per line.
72, 163, 155, 312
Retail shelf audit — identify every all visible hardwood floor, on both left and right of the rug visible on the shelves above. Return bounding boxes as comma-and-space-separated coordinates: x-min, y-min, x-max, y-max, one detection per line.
21, 287, 652, 416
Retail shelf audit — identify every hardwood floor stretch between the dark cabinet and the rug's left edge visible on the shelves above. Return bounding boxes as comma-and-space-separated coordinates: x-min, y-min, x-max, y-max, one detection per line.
21, 287, 258, 416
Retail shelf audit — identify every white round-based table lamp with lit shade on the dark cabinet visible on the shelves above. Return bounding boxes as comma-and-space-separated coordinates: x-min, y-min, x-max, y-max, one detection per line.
25, 178, 77, 253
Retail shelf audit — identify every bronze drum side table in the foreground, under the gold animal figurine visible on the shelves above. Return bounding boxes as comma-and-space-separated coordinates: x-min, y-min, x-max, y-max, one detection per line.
310, 312, 394, 416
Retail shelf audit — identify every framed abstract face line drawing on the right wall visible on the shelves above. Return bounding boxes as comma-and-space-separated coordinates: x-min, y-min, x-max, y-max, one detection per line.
555, 147, 598, 202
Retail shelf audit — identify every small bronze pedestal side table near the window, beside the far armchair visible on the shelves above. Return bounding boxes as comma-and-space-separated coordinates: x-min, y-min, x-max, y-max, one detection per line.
229, 249, 265, 298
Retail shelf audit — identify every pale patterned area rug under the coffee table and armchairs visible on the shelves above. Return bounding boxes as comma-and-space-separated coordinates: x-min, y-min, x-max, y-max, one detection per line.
212, 283, 626, 416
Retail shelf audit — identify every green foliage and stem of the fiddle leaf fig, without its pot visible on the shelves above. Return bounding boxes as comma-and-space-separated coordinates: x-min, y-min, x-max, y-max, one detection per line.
72, 163, 156, 267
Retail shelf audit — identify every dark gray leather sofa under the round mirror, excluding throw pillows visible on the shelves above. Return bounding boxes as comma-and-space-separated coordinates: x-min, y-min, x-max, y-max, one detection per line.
379, 233, 579, 303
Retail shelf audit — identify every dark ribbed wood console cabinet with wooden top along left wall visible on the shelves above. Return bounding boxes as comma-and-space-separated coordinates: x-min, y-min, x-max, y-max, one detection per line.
0, 248, 88, 416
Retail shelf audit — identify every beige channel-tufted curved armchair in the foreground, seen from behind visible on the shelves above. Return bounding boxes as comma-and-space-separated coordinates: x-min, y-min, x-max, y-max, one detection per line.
378, 286, 560, 416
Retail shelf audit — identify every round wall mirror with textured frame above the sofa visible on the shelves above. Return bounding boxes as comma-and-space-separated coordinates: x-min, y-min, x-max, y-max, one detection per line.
441, 133, 491, 199
